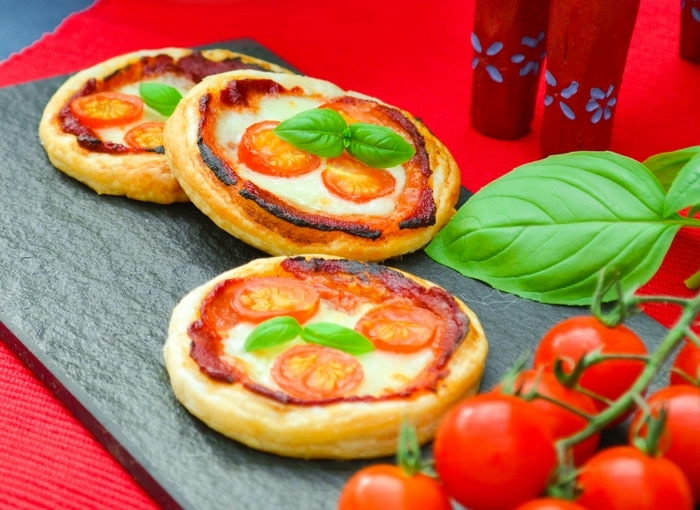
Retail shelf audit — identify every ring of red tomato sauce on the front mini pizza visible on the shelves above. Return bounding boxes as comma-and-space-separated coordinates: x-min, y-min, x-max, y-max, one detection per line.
188, 257, 469, 405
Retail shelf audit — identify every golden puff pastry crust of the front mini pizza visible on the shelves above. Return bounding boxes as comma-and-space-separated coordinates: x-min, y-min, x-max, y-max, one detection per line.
163, 255, 488, 459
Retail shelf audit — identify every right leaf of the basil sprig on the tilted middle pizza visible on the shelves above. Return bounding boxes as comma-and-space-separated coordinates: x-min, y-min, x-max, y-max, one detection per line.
347, 122, 416, 168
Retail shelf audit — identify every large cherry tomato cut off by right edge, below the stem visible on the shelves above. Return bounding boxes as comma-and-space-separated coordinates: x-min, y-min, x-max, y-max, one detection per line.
630, 385, 700, 503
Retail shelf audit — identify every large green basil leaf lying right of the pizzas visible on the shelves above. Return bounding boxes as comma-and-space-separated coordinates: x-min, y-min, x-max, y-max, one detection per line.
425, 152, 698, 305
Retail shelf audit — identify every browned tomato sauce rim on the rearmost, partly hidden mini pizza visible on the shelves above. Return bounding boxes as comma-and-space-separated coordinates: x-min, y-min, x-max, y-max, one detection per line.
58, 52, 274, 154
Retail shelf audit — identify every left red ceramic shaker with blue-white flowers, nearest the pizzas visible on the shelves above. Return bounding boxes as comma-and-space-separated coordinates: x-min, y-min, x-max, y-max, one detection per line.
470, 0, 550, 139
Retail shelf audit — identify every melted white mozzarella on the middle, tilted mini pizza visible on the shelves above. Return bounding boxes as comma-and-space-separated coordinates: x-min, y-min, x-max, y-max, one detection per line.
214, 96, 406, 217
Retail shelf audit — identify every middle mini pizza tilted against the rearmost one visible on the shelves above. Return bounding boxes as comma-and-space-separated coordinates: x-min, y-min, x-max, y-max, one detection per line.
164, 70, 460, 261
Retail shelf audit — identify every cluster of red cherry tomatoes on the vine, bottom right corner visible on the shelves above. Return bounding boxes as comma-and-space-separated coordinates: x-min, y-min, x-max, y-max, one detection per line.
338, 316, 700, 510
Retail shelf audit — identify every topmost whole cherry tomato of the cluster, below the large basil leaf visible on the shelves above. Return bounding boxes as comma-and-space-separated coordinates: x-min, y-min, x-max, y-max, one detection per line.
533, 316, 648, 424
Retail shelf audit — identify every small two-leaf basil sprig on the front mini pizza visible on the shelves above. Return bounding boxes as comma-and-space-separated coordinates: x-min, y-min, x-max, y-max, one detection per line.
243, 315, 374, 356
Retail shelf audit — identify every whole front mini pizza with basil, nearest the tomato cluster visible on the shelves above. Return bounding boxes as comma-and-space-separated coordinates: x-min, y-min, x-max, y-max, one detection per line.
163, 255, 488, 459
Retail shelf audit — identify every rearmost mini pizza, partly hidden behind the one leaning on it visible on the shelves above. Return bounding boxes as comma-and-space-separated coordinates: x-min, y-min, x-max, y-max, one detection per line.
39, 48, 289, 204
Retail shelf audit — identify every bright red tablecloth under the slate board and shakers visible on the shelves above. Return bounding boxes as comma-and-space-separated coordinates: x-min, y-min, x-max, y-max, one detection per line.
0, 0, 700, 509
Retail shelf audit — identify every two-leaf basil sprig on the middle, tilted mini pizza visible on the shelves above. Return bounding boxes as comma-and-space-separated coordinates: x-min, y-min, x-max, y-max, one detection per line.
274, 108, 416, 168
